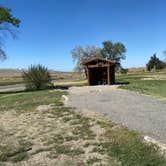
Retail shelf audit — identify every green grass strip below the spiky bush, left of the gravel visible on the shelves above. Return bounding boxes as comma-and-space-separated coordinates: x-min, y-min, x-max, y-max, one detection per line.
0, 90, 66, 112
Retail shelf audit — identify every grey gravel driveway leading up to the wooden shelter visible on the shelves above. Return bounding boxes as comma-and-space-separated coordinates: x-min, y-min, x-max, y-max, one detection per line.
67, 86, 166, 143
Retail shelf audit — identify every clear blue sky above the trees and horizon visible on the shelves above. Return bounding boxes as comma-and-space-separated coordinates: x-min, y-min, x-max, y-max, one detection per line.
0, 0, 166, 71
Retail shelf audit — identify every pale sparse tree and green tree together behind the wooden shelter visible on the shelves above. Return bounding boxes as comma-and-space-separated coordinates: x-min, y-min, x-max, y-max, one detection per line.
71, 40, 126, 72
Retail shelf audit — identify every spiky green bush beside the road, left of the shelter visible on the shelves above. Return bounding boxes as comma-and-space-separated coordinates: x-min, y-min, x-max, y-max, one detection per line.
23, 64, 51, 90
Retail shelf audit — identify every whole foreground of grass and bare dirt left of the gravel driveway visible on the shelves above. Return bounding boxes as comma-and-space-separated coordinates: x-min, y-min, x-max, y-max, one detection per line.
0, 90, 166, 166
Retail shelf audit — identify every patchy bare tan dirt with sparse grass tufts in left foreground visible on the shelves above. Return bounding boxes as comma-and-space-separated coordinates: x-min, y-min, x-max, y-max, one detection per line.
0, 93, 119, 166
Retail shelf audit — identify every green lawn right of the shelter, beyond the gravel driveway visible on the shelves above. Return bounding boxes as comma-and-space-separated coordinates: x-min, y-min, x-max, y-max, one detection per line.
117, 73, 166, 97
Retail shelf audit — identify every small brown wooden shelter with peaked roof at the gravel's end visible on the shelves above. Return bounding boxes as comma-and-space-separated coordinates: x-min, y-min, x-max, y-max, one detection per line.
82, 57, 118, 85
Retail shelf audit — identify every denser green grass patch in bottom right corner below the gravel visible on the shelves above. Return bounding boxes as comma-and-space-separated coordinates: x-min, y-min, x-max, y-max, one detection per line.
93, 124, 166, 166
